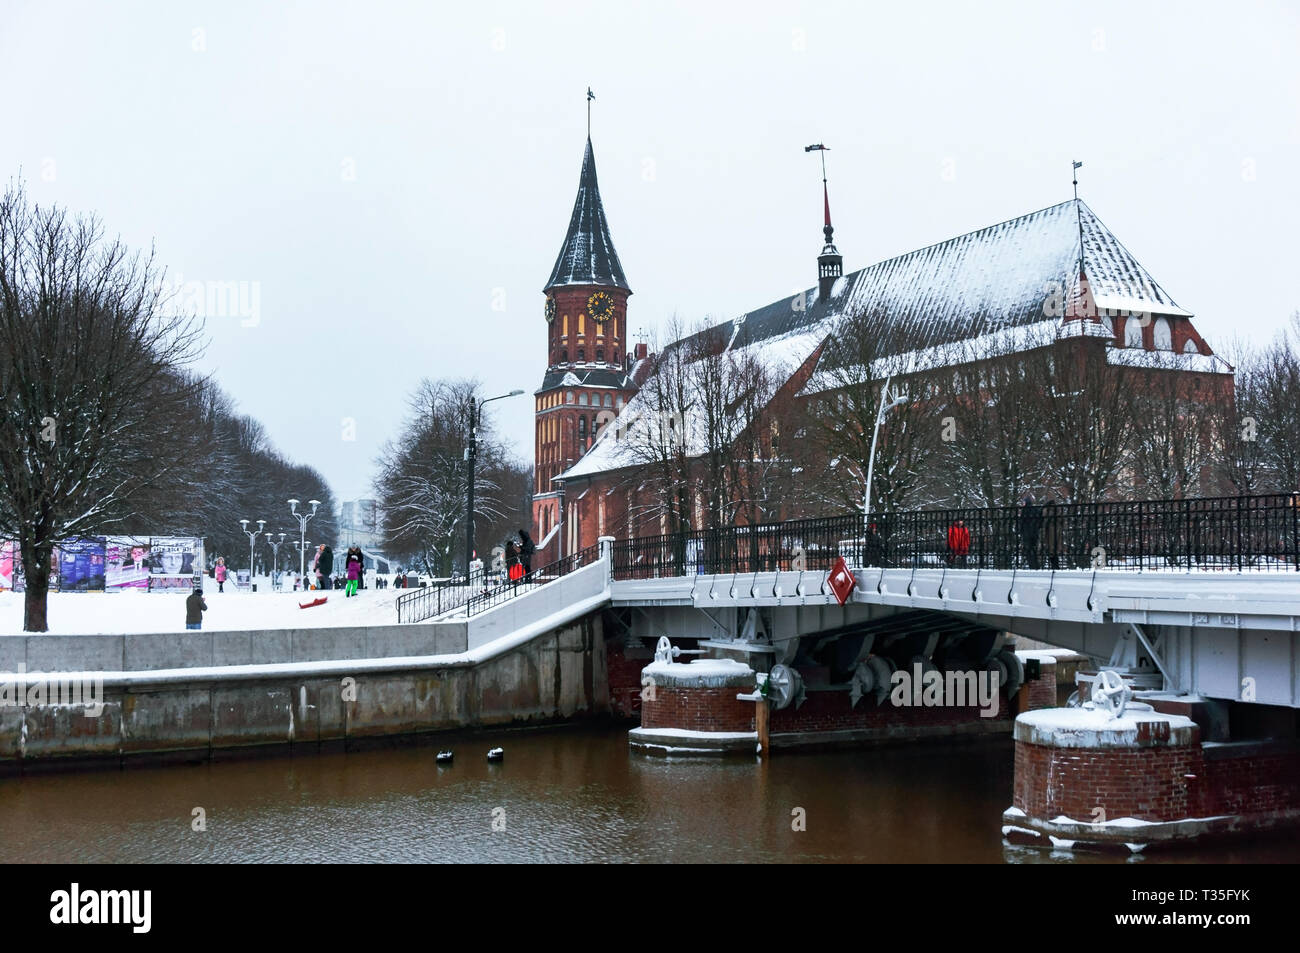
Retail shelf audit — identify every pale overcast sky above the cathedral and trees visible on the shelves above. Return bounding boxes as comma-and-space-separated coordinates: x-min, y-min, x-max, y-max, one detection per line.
0, 0, 1300, 501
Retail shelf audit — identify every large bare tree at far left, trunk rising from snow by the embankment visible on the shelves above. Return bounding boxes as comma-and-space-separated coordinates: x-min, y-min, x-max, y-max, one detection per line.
0, 185, 202, 632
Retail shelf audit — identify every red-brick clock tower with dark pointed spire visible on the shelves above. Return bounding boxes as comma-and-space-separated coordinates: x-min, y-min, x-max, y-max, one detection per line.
533, 137, 636, 567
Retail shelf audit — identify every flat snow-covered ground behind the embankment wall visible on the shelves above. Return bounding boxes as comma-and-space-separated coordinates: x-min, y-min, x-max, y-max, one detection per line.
0, 577, 411, 636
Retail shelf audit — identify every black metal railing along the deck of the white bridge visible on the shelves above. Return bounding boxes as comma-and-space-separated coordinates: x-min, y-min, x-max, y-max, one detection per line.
612, 494, 1300, 579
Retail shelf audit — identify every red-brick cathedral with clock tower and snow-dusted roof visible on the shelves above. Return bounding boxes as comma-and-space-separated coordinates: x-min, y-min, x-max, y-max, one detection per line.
533, 137, 1234, 566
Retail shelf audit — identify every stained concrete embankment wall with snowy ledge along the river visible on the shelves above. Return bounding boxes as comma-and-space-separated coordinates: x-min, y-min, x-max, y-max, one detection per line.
0, 611, 610, 771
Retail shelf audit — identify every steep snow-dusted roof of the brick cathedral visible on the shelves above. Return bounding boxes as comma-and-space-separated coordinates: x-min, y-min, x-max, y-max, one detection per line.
558, 197, 1201, 480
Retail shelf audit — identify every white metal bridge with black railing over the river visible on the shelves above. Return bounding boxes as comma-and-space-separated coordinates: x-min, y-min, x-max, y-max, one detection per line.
399, 494, 1300, 709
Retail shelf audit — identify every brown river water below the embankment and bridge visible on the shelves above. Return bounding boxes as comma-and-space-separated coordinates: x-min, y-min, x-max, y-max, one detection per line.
0, 727, 1300, 863
